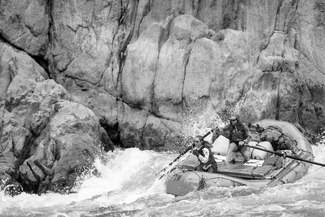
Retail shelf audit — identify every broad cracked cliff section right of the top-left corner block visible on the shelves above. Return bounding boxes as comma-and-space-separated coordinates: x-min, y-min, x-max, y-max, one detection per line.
47, 0, 137, 88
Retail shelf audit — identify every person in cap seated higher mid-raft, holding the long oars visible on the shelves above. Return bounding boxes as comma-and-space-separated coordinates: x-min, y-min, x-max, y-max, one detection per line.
212, 116, 250, 164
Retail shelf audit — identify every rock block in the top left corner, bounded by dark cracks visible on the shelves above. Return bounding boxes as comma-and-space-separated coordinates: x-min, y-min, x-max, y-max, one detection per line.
0, 0, 50, 56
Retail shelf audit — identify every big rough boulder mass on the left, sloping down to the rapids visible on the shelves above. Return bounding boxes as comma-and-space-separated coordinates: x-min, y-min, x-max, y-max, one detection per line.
0, 43, 114, 193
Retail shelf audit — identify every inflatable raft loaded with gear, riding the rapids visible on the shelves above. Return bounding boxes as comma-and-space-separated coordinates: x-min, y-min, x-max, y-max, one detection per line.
166, 120, 313, 196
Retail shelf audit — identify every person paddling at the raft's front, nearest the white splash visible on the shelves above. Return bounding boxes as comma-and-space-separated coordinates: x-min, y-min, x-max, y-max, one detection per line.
192, 136, 218, 173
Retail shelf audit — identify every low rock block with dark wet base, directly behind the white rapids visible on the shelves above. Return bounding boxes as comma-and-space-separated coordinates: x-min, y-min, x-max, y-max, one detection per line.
118, 100, 182, 150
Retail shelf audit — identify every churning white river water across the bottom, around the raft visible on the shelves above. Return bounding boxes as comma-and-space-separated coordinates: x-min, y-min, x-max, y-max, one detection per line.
0, 145, 325, 217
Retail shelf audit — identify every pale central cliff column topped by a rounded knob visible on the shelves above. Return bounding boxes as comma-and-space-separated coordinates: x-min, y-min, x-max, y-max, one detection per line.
153, 15, 210, 123
